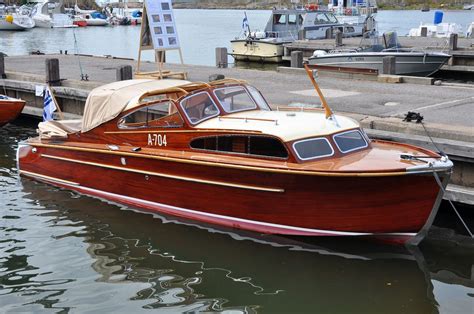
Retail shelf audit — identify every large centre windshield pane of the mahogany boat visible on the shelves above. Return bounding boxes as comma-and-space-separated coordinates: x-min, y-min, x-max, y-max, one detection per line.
214, 86, 257, 112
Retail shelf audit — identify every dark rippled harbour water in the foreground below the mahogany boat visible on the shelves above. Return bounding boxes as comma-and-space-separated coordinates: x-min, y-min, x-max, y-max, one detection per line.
0, 119, 474, 314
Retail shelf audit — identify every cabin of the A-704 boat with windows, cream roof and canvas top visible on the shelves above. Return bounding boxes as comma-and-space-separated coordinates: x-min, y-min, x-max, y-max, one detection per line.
39, 80, 370, 163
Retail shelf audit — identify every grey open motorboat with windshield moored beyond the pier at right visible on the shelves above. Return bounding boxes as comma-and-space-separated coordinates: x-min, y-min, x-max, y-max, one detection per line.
308, 32, 451, 76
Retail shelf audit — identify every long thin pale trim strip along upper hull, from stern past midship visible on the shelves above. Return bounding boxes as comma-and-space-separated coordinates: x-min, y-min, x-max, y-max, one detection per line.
41, 154, 285, 193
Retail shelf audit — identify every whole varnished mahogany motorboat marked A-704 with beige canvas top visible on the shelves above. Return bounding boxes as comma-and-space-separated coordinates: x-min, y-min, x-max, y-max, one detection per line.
18, 76, 452, 243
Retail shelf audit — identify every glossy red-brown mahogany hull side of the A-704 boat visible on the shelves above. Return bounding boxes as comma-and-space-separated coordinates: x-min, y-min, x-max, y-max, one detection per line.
18, 146, 439, 235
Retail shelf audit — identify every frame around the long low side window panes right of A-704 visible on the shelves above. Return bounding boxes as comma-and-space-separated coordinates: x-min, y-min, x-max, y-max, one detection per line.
189, 134, 291, 160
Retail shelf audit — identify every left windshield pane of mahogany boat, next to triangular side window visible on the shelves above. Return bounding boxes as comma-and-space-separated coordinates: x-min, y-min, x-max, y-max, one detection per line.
180, 92, 219, 124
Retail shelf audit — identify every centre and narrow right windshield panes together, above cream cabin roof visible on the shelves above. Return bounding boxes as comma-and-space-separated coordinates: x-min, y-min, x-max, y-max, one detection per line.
214, 86, 269, 113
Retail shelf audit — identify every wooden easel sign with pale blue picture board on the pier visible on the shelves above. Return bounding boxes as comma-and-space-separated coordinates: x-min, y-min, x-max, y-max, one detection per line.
135, 0, 187, 79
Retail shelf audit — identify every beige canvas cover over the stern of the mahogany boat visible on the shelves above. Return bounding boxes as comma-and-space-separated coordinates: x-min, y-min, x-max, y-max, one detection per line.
81, 79, 190, 132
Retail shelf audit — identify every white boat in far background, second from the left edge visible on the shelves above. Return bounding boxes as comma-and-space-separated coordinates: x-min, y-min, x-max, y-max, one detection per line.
32, 0, 77, 28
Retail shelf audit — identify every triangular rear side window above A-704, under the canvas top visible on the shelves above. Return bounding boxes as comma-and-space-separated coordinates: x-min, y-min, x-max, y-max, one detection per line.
118, 101, 183, 129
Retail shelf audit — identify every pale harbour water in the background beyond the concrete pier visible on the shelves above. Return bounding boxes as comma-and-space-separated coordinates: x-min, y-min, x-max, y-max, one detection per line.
0, 10, 474, 65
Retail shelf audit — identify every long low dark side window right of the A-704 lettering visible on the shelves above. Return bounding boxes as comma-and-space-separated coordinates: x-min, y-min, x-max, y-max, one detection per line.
190, 135, 288, 159
